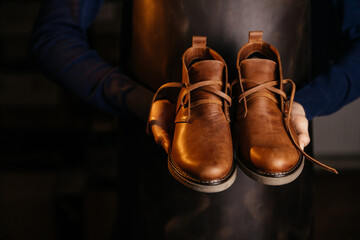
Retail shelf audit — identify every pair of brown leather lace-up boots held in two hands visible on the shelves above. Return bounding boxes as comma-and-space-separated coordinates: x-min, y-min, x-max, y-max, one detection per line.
148, 32, 336, 192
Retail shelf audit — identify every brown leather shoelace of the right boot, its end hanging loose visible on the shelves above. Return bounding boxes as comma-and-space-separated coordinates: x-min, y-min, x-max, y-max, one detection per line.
231, 79, 338, 174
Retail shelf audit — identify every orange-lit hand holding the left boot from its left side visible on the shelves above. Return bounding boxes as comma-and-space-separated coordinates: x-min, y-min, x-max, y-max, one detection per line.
147, 99, 176, 153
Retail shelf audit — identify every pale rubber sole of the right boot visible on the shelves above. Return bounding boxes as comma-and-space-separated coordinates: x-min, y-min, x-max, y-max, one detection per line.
237, 156, 305, 186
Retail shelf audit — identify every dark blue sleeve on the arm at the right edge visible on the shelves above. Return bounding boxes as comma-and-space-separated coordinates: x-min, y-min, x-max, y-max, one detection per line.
295, 0, 360, 120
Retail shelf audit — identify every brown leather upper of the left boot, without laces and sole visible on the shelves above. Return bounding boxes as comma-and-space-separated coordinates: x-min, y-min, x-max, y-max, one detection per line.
170, 38, 233, 182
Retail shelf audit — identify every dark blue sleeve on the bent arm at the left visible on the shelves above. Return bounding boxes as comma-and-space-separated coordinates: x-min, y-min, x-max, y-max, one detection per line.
31, 0, 153, 119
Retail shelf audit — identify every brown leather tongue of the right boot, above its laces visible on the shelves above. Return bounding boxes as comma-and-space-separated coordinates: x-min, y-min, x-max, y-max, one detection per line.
240, 58, 277, 89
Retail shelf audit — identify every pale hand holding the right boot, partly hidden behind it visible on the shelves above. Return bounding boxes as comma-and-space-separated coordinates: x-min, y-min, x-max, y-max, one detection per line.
291, 102, 310, 150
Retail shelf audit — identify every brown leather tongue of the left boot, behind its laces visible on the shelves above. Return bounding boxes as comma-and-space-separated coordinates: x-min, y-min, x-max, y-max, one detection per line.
189, 60, 225, 101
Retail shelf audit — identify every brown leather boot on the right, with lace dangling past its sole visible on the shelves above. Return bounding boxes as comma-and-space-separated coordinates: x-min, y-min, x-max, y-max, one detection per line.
233, 32, 336, 185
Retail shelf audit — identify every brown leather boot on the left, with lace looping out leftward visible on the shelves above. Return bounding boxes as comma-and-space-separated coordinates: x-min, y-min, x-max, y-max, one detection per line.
148, 37, 236, 192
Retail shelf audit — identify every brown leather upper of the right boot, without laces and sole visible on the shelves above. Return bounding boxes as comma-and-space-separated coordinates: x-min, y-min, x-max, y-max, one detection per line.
234, 59, 300, 173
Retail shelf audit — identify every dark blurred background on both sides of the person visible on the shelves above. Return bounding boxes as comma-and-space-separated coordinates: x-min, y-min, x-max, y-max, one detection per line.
0, 0, 360, 240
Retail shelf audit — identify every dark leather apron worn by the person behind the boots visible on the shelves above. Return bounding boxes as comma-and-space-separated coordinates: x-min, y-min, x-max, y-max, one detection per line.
119, 0, 313, 240
